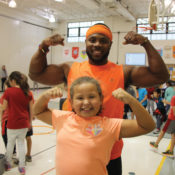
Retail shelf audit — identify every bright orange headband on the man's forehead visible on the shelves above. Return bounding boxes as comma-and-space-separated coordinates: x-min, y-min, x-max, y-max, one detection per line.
86, 24, 112, 41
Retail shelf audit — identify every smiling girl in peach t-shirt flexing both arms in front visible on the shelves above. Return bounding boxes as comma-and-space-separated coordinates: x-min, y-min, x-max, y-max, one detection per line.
33, 77, 155, 175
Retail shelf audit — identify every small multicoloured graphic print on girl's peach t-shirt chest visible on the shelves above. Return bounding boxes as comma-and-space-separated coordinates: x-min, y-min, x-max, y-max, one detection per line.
85, 124, 103, 136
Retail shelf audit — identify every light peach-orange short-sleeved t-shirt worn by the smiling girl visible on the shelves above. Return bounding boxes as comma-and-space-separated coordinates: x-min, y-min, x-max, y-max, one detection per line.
52, 110, 122, 175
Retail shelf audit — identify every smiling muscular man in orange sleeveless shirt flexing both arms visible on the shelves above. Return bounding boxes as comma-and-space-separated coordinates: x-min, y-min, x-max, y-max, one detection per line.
29, 24, 169, 175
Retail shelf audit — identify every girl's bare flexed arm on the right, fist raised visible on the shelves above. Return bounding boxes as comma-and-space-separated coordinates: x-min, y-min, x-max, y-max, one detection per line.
113, 88, 155, 138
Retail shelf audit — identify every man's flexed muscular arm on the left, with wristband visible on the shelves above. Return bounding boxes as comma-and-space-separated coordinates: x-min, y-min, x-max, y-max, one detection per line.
29, 34, 71, 85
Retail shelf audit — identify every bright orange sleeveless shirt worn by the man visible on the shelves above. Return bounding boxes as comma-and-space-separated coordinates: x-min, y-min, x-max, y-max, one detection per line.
68, 61, 124, 159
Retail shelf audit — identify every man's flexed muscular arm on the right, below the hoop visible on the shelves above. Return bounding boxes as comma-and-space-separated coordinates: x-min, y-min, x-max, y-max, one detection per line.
124, 32, 169, 87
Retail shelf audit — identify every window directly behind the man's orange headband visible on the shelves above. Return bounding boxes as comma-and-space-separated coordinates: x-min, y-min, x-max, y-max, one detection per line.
67, 21, 104, 42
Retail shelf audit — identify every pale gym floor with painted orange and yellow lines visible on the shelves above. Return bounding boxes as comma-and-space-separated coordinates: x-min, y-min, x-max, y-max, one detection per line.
0, 90, 175, 175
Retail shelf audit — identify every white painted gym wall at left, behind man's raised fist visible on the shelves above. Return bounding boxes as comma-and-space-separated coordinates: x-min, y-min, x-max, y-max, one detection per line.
0, 16, 52, 87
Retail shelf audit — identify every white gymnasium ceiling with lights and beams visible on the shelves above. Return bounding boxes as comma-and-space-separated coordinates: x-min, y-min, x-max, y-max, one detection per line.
0, 0, 174, 22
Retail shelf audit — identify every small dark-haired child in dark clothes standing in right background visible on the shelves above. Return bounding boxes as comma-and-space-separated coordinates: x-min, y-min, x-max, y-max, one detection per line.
153, 88, 166, 134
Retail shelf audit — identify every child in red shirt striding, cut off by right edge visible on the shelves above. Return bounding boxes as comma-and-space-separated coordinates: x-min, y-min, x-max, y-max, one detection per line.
150, 96, 175, 157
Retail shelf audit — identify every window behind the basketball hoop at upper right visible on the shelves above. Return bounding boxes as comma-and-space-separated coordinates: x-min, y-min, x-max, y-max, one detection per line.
136, 17, 175, 40
